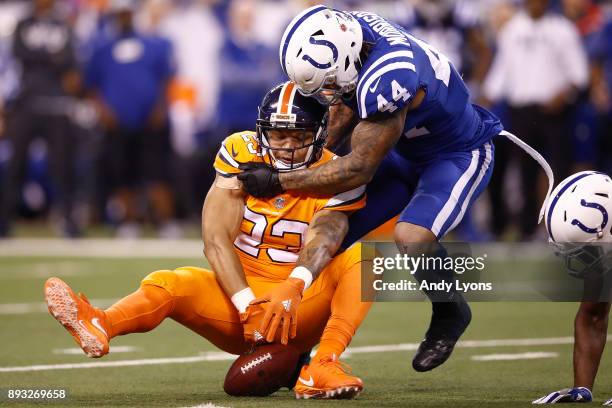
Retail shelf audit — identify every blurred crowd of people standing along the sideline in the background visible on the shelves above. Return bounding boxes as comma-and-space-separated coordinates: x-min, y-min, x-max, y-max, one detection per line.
0, 0, 612, 240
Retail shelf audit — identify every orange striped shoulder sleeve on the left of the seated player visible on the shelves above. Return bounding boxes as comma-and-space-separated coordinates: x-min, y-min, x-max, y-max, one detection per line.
214, 133, 256, 178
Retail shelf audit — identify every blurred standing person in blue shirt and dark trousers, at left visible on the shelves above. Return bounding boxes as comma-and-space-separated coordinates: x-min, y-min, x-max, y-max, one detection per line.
86, 0, 174, 237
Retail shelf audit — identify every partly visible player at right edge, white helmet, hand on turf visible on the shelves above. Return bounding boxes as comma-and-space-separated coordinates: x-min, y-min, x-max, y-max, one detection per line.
533, 171, 612, 405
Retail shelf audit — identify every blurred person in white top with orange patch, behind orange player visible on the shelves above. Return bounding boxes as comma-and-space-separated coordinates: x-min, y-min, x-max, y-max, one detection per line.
151, 0, 224, 218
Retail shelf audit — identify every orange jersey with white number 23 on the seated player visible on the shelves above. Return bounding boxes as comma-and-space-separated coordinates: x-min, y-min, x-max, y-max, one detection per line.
214, 132, 365, 279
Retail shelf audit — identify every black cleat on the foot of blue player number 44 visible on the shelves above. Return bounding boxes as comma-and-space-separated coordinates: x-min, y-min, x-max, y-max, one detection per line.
412, 301, 472, 372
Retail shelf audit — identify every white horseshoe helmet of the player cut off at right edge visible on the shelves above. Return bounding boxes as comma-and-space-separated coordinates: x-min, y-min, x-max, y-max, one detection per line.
545, 171, 612, 276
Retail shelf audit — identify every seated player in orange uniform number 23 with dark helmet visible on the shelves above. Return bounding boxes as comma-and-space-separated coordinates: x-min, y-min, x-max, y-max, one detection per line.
45, 82, 371, 398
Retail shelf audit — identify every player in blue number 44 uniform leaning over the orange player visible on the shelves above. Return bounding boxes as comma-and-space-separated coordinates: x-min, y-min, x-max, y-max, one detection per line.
239, 5, 552, 371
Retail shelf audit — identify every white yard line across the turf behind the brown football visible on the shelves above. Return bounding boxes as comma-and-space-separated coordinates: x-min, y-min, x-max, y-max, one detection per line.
0, 335, 612, 373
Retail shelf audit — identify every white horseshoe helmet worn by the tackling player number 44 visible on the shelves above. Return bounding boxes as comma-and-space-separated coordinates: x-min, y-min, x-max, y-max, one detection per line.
279, 5, 363, 104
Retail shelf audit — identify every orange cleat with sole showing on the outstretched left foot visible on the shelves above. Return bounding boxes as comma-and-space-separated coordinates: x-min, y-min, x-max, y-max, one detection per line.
45, 278, 109, 358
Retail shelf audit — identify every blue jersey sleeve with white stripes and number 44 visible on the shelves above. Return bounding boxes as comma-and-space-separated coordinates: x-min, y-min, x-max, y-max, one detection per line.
356, 58, 418, 119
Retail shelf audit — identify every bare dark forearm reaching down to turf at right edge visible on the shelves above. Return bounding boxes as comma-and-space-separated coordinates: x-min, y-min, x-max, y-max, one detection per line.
574, 302, 610, 390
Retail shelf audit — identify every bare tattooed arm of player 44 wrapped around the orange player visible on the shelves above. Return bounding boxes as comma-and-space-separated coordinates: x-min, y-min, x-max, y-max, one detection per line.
279, 107, 409, 194
